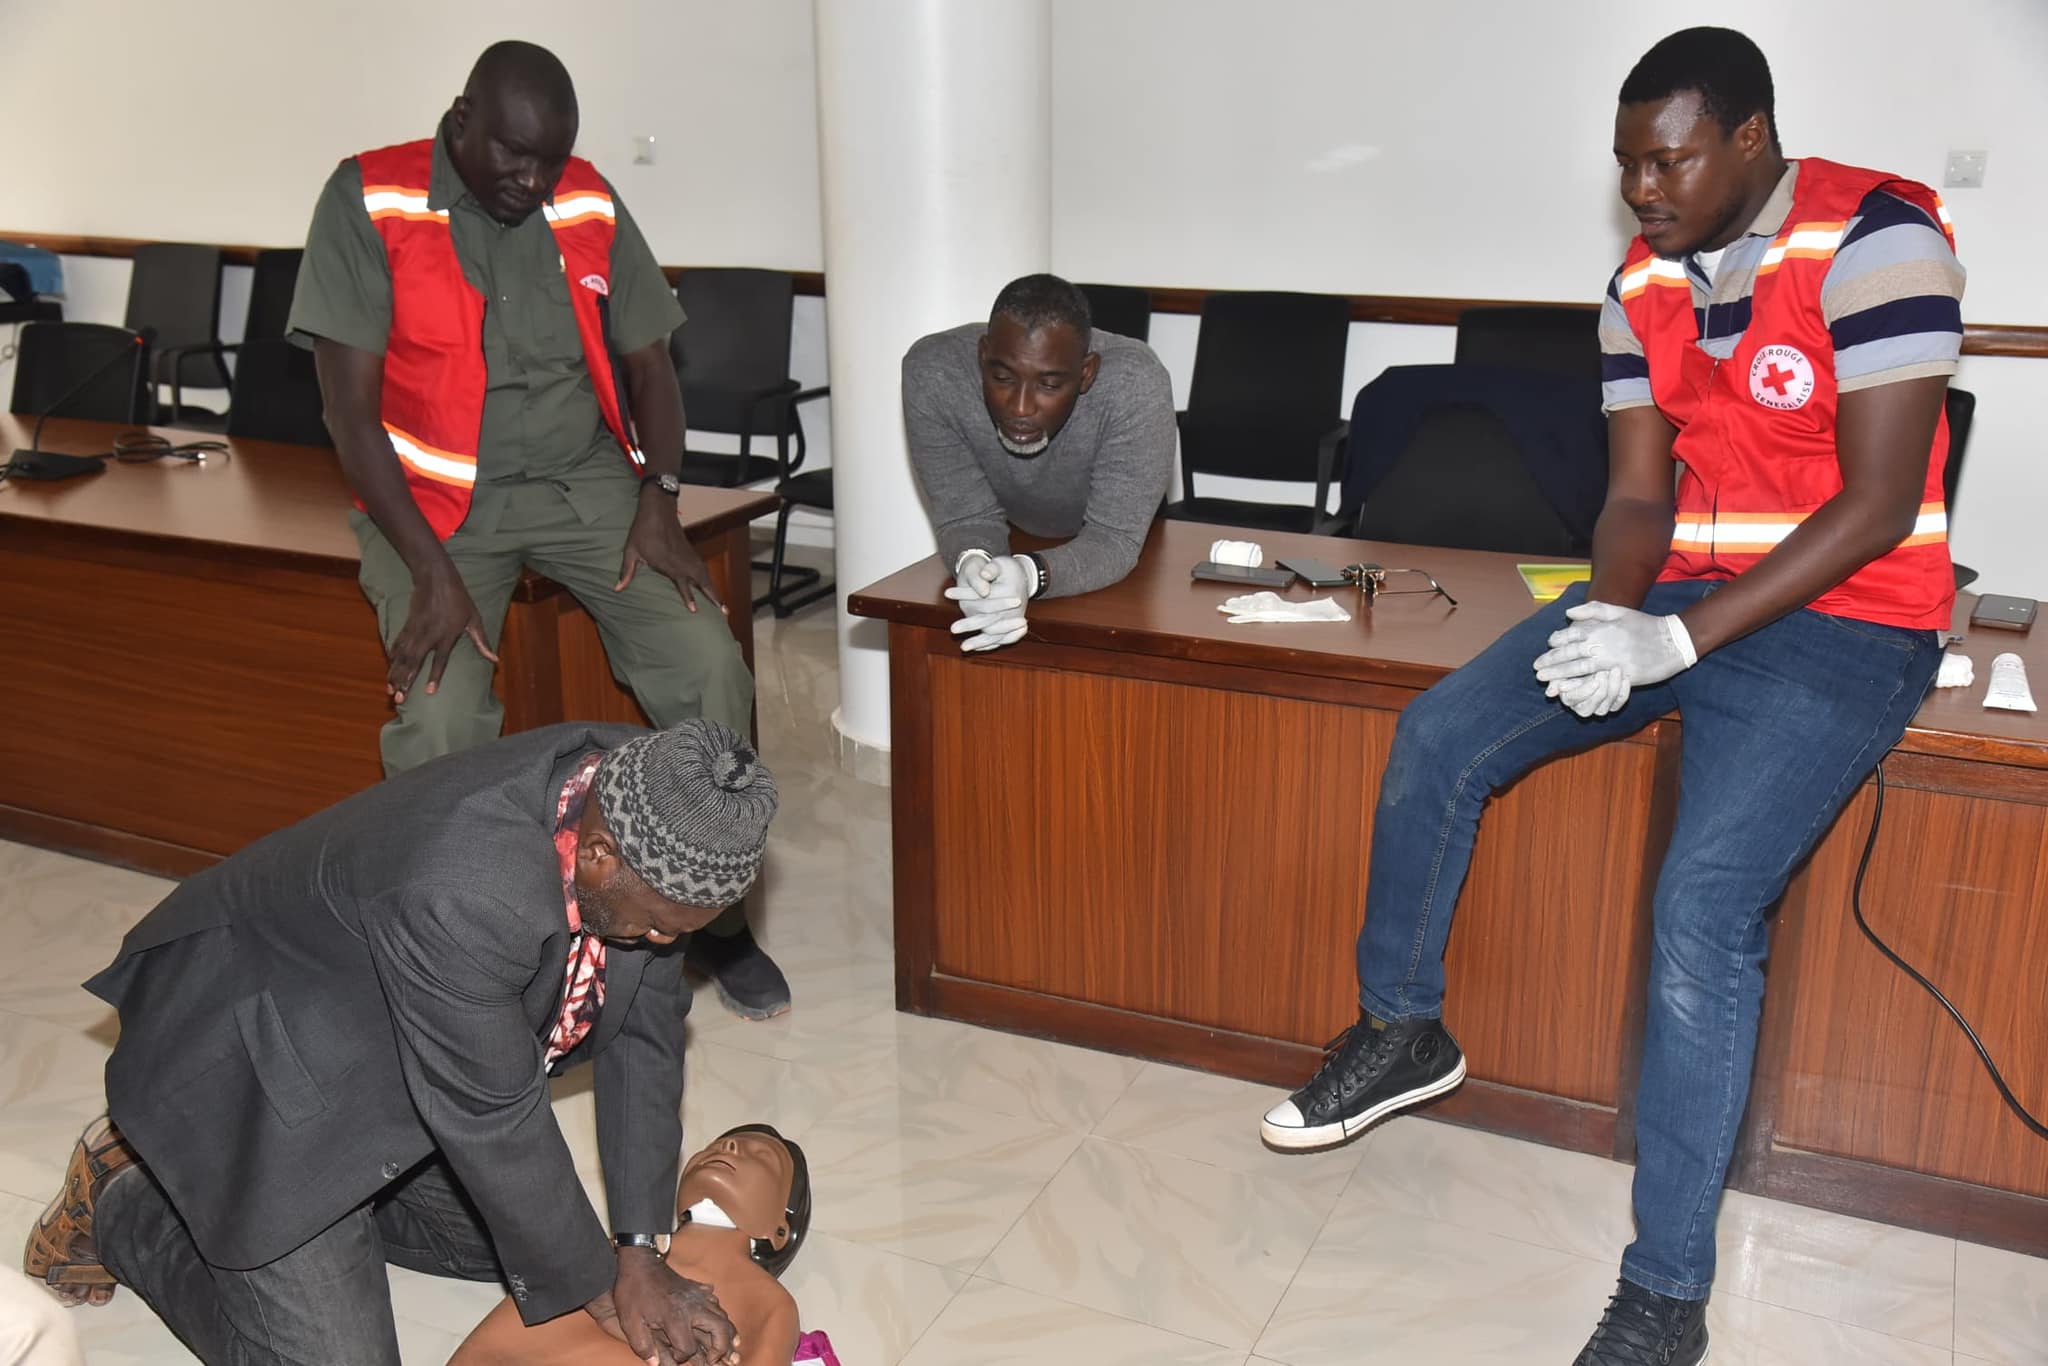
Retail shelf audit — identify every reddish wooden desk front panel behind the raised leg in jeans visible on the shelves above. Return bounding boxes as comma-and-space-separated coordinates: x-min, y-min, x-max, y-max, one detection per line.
909, 627, 1661, 1151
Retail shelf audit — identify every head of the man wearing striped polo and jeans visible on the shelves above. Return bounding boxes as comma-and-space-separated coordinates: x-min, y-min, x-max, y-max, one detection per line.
1614, 29, 1786, 258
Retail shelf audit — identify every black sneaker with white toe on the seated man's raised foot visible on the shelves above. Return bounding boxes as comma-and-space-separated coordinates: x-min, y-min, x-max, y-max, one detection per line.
1260, 1010, 1464, 1151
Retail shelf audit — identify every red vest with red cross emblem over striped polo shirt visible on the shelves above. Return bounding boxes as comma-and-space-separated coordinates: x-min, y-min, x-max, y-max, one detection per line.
1620, 158, 1956, 631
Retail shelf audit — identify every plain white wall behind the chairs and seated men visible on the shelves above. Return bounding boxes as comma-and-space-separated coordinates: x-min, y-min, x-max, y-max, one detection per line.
0, 0, 2048, 598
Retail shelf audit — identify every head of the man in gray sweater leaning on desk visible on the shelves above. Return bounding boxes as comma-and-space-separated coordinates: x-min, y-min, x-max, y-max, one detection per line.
979, 274, 1102, 459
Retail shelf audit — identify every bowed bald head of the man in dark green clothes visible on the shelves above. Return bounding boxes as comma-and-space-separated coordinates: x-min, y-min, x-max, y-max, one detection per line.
442, 41, 578, 227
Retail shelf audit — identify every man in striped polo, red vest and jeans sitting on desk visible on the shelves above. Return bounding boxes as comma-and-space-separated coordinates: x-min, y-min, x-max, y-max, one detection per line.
1262, 29, 1962, 1366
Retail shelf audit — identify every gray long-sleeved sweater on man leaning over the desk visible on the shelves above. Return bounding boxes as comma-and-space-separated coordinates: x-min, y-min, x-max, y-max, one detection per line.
903, 324, 1176, 598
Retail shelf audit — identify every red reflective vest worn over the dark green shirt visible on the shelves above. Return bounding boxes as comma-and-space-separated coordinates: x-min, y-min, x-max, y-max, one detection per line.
356, 137, 645, 541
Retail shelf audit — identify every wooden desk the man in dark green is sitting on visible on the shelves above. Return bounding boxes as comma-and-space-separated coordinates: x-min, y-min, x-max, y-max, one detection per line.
0, 416, 776, 877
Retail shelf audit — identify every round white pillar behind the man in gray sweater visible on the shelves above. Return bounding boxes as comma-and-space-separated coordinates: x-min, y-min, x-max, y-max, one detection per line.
813, 0, 1053, 776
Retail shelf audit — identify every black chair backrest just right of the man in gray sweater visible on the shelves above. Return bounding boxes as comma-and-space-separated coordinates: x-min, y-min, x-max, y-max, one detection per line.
1188, 291, 1352, 417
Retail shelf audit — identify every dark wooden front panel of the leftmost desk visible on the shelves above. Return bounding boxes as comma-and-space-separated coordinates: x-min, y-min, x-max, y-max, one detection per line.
0, 524, 389, 874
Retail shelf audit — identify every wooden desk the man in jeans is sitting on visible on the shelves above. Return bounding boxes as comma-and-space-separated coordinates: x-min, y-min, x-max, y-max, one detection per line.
850, 522, 2048, 1253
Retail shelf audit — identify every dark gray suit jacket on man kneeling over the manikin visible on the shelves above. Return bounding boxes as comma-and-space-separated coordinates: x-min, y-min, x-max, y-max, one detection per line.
86, 725, 690, 1323
